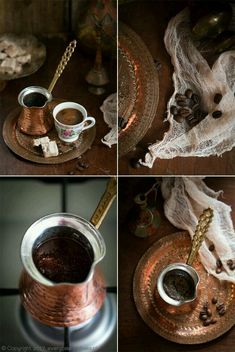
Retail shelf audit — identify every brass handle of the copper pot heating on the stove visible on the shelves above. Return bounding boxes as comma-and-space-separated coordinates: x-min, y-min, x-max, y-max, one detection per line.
90, 177, 117, 229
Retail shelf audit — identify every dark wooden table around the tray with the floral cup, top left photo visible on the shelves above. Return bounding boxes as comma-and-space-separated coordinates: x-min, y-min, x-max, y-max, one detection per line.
0, 36, 117, 175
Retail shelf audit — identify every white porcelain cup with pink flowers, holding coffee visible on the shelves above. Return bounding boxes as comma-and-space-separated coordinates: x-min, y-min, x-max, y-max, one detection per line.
53, 102, 96, 142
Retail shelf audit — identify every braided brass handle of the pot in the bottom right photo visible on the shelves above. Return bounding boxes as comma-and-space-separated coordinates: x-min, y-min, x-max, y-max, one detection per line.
187, 208, 213, 265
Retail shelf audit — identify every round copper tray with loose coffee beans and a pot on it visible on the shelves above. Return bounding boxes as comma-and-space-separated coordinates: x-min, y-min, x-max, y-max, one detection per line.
133, 232, 235, 344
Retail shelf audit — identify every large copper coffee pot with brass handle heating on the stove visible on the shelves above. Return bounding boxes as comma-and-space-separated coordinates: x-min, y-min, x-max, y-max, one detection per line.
20, 178, 116, 327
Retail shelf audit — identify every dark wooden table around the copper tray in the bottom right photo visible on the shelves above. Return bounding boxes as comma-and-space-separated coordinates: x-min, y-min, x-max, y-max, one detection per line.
119, 177, 235, 352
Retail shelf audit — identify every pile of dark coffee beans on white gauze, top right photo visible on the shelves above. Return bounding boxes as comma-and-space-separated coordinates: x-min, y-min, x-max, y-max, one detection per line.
170, 89, 207, 127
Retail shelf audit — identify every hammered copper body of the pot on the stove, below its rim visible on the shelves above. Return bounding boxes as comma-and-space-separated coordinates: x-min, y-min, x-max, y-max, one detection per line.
20, 269, 106, 326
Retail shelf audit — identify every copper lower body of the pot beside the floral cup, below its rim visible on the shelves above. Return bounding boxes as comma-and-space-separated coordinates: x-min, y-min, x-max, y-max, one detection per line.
17, 105, 53, 136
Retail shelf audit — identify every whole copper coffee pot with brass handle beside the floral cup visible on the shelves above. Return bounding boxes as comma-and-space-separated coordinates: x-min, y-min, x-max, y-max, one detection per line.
18, 40, 77, 136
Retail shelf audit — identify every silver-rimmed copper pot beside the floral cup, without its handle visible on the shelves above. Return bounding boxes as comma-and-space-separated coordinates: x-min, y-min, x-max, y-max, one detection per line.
18, 86, 53, 136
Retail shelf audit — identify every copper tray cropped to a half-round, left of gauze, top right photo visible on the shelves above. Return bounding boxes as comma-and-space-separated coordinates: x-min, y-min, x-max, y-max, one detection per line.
118, 23, 159, 156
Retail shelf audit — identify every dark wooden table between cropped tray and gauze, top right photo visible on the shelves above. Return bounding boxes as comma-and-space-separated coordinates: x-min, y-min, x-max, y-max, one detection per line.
119, 0, 235, 175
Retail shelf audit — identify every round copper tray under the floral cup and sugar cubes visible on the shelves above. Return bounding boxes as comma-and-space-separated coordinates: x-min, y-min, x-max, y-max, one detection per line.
3, 101, 96, 164
